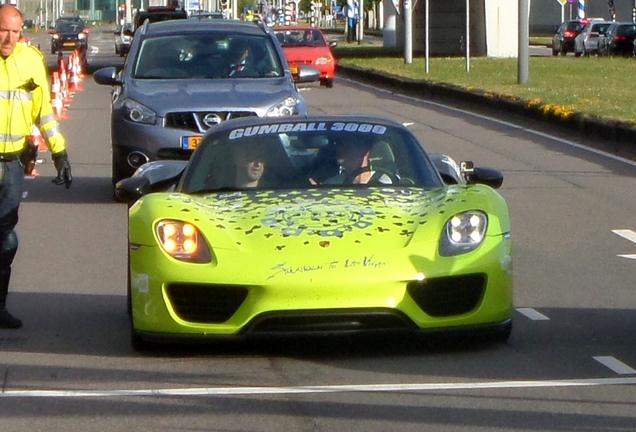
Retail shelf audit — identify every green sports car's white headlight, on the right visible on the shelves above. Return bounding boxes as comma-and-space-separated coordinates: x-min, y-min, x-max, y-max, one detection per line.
439, 211, 488, 256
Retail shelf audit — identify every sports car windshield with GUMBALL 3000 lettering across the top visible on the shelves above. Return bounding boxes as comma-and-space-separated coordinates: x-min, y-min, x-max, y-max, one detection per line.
181, 121, 442, 193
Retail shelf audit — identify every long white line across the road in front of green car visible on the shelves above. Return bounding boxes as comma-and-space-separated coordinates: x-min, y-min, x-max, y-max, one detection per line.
0, 377, 636, 398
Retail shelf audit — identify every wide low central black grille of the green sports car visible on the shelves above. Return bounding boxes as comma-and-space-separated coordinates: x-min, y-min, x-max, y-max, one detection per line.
248, 309, 416, 335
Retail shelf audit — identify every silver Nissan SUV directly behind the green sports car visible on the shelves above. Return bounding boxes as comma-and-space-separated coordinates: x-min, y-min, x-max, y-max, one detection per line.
93, 20, 320, 185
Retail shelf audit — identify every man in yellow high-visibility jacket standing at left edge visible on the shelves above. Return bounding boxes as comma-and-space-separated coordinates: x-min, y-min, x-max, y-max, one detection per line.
0, 4, 73, 328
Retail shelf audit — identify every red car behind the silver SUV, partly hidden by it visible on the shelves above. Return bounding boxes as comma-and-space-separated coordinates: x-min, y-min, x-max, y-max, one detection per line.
274, 26, 337, 88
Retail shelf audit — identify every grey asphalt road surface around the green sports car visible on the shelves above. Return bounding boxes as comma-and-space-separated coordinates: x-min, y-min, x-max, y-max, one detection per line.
0, 27, 636, 432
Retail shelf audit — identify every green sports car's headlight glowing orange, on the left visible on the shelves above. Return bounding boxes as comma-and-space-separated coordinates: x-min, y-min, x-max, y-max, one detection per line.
156, 220, 212, 264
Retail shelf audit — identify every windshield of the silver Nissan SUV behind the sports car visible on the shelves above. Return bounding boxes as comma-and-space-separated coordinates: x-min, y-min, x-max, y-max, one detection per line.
134, 32, 284, 79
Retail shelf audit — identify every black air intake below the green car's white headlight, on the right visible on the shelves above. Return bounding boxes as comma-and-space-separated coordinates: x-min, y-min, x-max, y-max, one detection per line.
408, 274, 487, 317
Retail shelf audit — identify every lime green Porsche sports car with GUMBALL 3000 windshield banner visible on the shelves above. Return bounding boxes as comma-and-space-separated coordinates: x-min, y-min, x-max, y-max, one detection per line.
116, 116, 513, 348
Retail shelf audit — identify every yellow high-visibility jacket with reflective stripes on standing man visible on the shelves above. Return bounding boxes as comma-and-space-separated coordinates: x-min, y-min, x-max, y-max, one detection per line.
0, 43, 66, 154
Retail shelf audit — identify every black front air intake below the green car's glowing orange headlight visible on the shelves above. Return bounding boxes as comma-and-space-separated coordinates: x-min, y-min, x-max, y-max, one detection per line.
166, 284, 248, 324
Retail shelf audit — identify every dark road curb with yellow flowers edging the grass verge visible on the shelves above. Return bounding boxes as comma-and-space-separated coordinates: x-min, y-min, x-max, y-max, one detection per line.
337, 65, 636, 150
